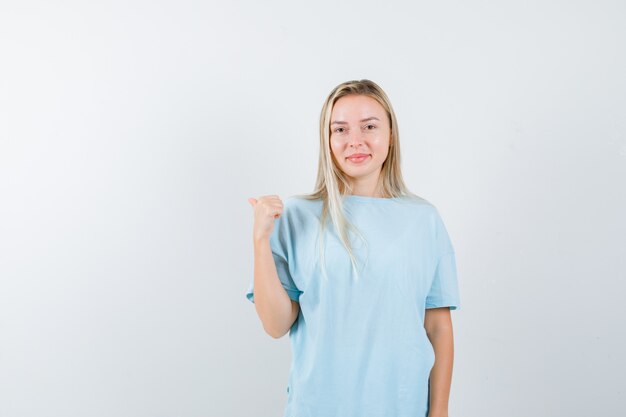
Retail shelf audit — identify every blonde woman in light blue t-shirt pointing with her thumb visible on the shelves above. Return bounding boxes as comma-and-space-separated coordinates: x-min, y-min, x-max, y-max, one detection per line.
246, 80, 460, 417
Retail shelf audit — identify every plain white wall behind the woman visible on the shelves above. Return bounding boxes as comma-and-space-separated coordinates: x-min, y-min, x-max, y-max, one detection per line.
0, 0, 626, 417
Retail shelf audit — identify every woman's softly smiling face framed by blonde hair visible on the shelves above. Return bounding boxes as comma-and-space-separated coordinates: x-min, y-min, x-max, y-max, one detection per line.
330, 94, 391, 184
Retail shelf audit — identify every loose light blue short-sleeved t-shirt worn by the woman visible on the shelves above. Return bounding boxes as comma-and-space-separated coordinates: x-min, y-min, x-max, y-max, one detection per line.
246, 195, 460, 417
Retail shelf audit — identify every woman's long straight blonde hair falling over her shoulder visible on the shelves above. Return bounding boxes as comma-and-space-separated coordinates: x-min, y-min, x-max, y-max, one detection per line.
295, 79, 421, 279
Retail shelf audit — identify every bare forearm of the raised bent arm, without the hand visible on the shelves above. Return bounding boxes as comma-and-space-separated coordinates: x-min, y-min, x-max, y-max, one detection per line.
254, 238, 300, 339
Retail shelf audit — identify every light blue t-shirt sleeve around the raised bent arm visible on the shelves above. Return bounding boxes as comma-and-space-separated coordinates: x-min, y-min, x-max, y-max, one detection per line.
246, 202, 302, 303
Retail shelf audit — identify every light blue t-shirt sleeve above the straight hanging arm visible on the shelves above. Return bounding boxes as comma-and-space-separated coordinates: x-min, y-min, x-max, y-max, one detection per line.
426, 213, 461, 310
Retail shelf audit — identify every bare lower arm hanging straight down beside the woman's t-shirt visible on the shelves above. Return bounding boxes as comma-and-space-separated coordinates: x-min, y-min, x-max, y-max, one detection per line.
424, 307, 454, 417
